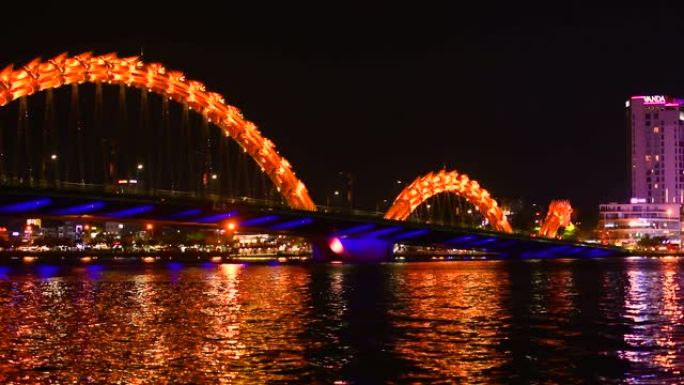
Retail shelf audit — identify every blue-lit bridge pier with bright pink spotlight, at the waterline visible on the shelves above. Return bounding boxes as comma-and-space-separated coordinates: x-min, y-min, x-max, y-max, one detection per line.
311, 237, 394, 263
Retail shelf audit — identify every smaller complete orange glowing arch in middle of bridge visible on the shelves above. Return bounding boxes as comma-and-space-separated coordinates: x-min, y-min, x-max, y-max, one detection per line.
385, 170, 513, 233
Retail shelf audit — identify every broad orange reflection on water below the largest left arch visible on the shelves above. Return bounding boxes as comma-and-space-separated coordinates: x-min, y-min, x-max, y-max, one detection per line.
0, 265, 307, 383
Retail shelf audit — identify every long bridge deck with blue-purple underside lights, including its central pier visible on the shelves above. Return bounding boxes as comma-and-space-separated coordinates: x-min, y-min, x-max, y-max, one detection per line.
0, 189, 626, 262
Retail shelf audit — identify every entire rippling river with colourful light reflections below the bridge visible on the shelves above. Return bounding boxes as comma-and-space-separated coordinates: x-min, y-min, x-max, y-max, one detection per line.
0, 258, 684, 384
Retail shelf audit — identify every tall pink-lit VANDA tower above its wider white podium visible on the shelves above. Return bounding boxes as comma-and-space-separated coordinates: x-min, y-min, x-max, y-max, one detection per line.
626, 95, 684, 203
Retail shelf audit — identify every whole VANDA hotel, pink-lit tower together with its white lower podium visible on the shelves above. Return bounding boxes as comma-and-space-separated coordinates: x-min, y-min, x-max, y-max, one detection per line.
597, 95, 684, 246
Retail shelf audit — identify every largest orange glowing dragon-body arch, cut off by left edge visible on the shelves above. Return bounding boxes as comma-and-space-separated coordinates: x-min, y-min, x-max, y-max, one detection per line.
0, 53, 316, 210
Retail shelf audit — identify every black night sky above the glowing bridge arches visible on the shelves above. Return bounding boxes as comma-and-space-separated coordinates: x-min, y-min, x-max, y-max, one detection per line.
0, 1, 684, 219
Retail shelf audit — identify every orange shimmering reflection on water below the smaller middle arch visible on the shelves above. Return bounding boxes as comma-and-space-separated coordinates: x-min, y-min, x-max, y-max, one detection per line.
395, 262, 509, 383
